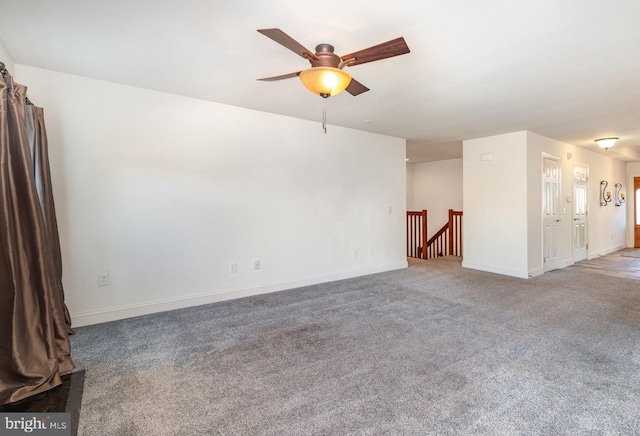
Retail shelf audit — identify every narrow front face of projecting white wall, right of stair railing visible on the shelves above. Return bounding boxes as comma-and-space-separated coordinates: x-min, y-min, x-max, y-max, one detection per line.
462, 132, 528, 278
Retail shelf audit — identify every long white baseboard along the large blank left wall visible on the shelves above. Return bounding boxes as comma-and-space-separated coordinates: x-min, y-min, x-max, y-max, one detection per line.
71, 262, 408, 327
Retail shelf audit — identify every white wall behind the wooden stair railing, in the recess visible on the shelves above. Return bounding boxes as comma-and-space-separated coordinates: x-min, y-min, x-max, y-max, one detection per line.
410, 159, 462, 237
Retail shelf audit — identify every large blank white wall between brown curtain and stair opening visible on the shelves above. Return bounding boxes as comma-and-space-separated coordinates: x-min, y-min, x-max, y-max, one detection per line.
16, 64, 407, 325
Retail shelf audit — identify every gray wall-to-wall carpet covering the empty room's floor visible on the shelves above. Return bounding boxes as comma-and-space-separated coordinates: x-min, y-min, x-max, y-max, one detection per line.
72, 258, 640, 436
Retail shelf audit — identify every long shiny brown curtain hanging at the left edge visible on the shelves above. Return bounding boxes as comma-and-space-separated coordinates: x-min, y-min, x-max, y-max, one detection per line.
0, 63, 74, 404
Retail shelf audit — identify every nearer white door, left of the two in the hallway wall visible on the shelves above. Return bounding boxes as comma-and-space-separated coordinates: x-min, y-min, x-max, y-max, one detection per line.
542, 157, 560, 272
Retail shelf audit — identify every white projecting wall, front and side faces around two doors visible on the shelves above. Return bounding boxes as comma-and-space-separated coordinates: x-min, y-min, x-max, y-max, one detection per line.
462, 132, 632, 278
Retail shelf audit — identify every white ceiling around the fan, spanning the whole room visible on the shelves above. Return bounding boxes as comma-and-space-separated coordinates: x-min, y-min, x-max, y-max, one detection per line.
0, 0, 640, 162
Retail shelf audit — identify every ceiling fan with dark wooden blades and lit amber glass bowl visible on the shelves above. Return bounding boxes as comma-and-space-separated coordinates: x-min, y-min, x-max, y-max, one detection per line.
258, 28, 410, 98
